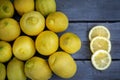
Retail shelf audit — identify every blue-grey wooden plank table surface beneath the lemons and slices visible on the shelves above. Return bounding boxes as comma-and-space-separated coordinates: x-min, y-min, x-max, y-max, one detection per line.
50, 0, 120, 80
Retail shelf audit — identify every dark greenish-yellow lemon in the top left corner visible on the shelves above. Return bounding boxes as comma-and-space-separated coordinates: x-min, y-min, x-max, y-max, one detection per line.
0, 0, 14, 18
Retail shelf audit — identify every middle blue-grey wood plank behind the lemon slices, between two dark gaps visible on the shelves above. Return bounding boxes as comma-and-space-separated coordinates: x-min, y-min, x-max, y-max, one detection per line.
62, 23, 120, 59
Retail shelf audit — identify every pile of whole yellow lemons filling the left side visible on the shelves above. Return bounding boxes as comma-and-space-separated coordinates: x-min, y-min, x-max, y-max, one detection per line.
0, 0, 81, 80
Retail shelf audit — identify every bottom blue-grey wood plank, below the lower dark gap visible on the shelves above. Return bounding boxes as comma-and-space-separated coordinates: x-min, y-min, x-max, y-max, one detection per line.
50, 61, 120, 80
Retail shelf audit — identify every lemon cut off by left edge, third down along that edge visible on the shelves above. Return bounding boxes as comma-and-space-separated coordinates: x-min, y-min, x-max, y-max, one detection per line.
0, 41, 12, 62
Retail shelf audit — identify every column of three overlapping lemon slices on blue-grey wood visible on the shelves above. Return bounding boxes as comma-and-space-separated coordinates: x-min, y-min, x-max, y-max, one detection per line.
89, 25, 111, 70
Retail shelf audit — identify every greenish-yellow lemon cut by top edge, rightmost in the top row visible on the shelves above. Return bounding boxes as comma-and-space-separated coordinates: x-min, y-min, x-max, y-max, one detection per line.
36, 0, 56, 16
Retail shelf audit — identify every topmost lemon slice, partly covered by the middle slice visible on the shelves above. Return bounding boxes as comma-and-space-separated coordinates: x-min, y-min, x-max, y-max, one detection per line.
89, 26, 110, 41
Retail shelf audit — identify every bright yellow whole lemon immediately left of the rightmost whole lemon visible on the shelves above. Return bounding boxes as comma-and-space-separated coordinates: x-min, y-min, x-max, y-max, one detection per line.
35, 31, 58, 56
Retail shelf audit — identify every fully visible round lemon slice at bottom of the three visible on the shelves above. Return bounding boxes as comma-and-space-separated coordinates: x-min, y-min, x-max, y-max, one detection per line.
91, 50, 111, 70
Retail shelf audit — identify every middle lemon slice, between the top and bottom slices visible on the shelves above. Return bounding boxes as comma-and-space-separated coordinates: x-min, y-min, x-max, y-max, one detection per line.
90, 36, 111, 53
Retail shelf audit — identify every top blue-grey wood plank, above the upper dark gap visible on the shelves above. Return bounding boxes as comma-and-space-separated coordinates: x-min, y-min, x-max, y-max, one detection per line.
56, 0, 120, 21
